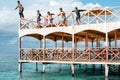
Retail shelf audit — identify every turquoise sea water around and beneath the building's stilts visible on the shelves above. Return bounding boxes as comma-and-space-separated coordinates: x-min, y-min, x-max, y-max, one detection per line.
0, 53, 120, 80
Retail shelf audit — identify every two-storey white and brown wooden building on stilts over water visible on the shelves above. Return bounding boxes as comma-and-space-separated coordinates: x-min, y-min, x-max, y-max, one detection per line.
18, 7, 120, 76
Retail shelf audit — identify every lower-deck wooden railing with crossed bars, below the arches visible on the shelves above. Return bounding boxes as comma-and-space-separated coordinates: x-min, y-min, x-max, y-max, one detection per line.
20, 47, 120, 62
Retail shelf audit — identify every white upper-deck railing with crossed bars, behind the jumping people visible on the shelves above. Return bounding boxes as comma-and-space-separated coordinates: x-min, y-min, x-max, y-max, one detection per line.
19, 6, 120, 30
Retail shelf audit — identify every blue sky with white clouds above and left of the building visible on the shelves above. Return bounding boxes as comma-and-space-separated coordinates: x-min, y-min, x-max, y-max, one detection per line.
0, 0, 120, 53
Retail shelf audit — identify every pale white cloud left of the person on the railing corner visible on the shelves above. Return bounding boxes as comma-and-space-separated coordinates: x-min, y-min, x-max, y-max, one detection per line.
0, 8, 18, 31
